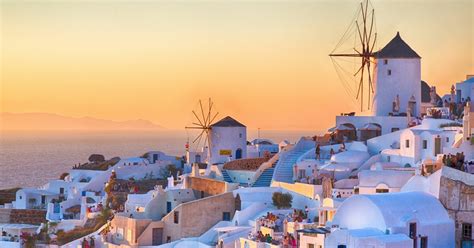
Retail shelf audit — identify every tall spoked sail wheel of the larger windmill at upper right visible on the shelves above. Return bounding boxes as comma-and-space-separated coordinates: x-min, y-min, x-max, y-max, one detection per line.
329, 0, 377, 111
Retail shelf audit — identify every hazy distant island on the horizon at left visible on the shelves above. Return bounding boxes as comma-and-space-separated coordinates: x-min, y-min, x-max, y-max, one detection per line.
0, 112, 164, 130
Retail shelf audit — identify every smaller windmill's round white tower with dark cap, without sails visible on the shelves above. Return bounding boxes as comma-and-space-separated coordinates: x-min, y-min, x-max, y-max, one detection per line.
210, 116, 247, 164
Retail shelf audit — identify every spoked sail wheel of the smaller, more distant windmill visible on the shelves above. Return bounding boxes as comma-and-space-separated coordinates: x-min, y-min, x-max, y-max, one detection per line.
185, 98, 219, 168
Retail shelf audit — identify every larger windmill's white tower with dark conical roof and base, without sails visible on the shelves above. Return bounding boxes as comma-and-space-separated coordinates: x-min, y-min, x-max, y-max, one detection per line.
336, 33, 422, 141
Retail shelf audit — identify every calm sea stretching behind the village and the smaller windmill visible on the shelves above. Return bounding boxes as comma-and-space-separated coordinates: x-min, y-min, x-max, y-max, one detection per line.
0, 130, 315, 189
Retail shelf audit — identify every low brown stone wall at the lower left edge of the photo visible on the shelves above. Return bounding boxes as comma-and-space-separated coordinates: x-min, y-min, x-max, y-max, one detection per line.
0, 209, 46, 225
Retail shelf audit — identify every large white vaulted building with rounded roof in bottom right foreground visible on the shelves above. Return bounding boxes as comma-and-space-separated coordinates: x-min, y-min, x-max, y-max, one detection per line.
325, 192, 455, 248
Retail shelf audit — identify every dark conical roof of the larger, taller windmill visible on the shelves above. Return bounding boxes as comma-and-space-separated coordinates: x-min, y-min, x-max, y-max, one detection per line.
375, 32, 421, 58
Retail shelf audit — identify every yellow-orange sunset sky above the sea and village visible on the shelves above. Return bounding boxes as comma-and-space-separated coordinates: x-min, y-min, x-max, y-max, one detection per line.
0, 0, 474, 130
